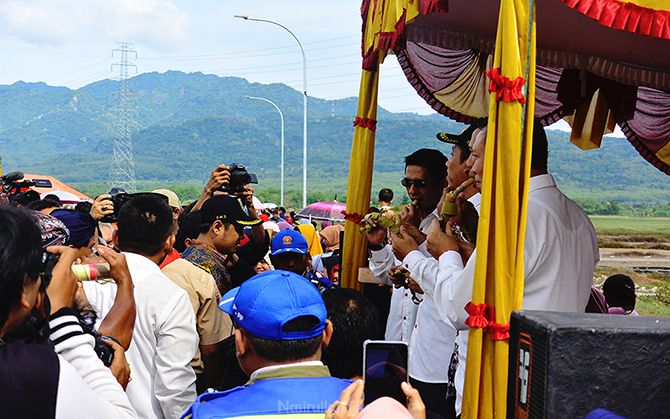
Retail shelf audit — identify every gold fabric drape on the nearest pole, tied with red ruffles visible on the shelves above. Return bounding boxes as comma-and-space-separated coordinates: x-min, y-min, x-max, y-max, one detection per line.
462, 0, 535, 419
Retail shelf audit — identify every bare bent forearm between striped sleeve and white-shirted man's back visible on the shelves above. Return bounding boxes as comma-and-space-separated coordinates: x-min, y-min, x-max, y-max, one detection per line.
98, 246, 137, 350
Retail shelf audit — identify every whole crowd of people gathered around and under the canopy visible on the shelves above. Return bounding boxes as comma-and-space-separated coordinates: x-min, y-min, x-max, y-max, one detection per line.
0, 121, 636, 418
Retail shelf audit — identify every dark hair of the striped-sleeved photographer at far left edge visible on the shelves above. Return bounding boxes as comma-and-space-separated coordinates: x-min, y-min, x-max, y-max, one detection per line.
0, 205, 42, 327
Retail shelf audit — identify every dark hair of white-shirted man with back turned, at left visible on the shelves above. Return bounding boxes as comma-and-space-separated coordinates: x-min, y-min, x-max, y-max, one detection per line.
118, 195, 174, 256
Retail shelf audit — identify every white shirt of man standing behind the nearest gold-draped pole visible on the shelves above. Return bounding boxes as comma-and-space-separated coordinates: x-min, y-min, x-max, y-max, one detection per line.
435, 174, 600, 412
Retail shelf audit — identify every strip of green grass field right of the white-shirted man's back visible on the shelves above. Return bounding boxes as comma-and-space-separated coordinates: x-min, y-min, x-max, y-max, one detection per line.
591, 215, 670, 238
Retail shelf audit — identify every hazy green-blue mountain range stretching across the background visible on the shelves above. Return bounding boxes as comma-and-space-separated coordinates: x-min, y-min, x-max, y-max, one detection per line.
0, 71, 670, 203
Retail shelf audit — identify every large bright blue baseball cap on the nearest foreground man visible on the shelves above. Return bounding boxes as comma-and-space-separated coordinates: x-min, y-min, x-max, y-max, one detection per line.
219, 270, 327, 340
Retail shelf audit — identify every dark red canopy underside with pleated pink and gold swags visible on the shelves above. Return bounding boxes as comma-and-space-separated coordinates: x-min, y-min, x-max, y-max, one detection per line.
384, 0, 670, 175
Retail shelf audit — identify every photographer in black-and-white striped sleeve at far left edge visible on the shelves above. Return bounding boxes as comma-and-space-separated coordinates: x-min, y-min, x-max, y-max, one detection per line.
0, 206, 137, 418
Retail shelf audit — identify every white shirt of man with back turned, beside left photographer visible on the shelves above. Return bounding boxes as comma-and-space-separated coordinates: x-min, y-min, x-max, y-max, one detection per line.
83, 253, 198, 419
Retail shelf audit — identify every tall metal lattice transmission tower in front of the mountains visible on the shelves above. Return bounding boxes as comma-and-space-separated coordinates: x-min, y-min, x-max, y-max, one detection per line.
109, 42, 137, 192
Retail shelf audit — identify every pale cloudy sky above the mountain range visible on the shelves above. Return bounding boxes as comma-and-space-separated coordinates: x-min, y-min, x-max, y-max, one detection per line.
0, 0, 624, 134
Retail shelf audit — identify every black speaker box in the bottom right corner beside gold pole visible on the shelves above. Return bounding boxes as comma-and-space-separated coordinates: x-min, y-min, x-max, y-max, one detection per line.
507, 311, 670, 419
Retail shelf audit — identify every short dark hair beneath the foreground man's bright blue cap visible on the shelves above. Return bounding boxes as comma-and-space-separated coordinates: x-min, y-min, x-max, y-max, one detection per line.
247, 316, 322, 362
